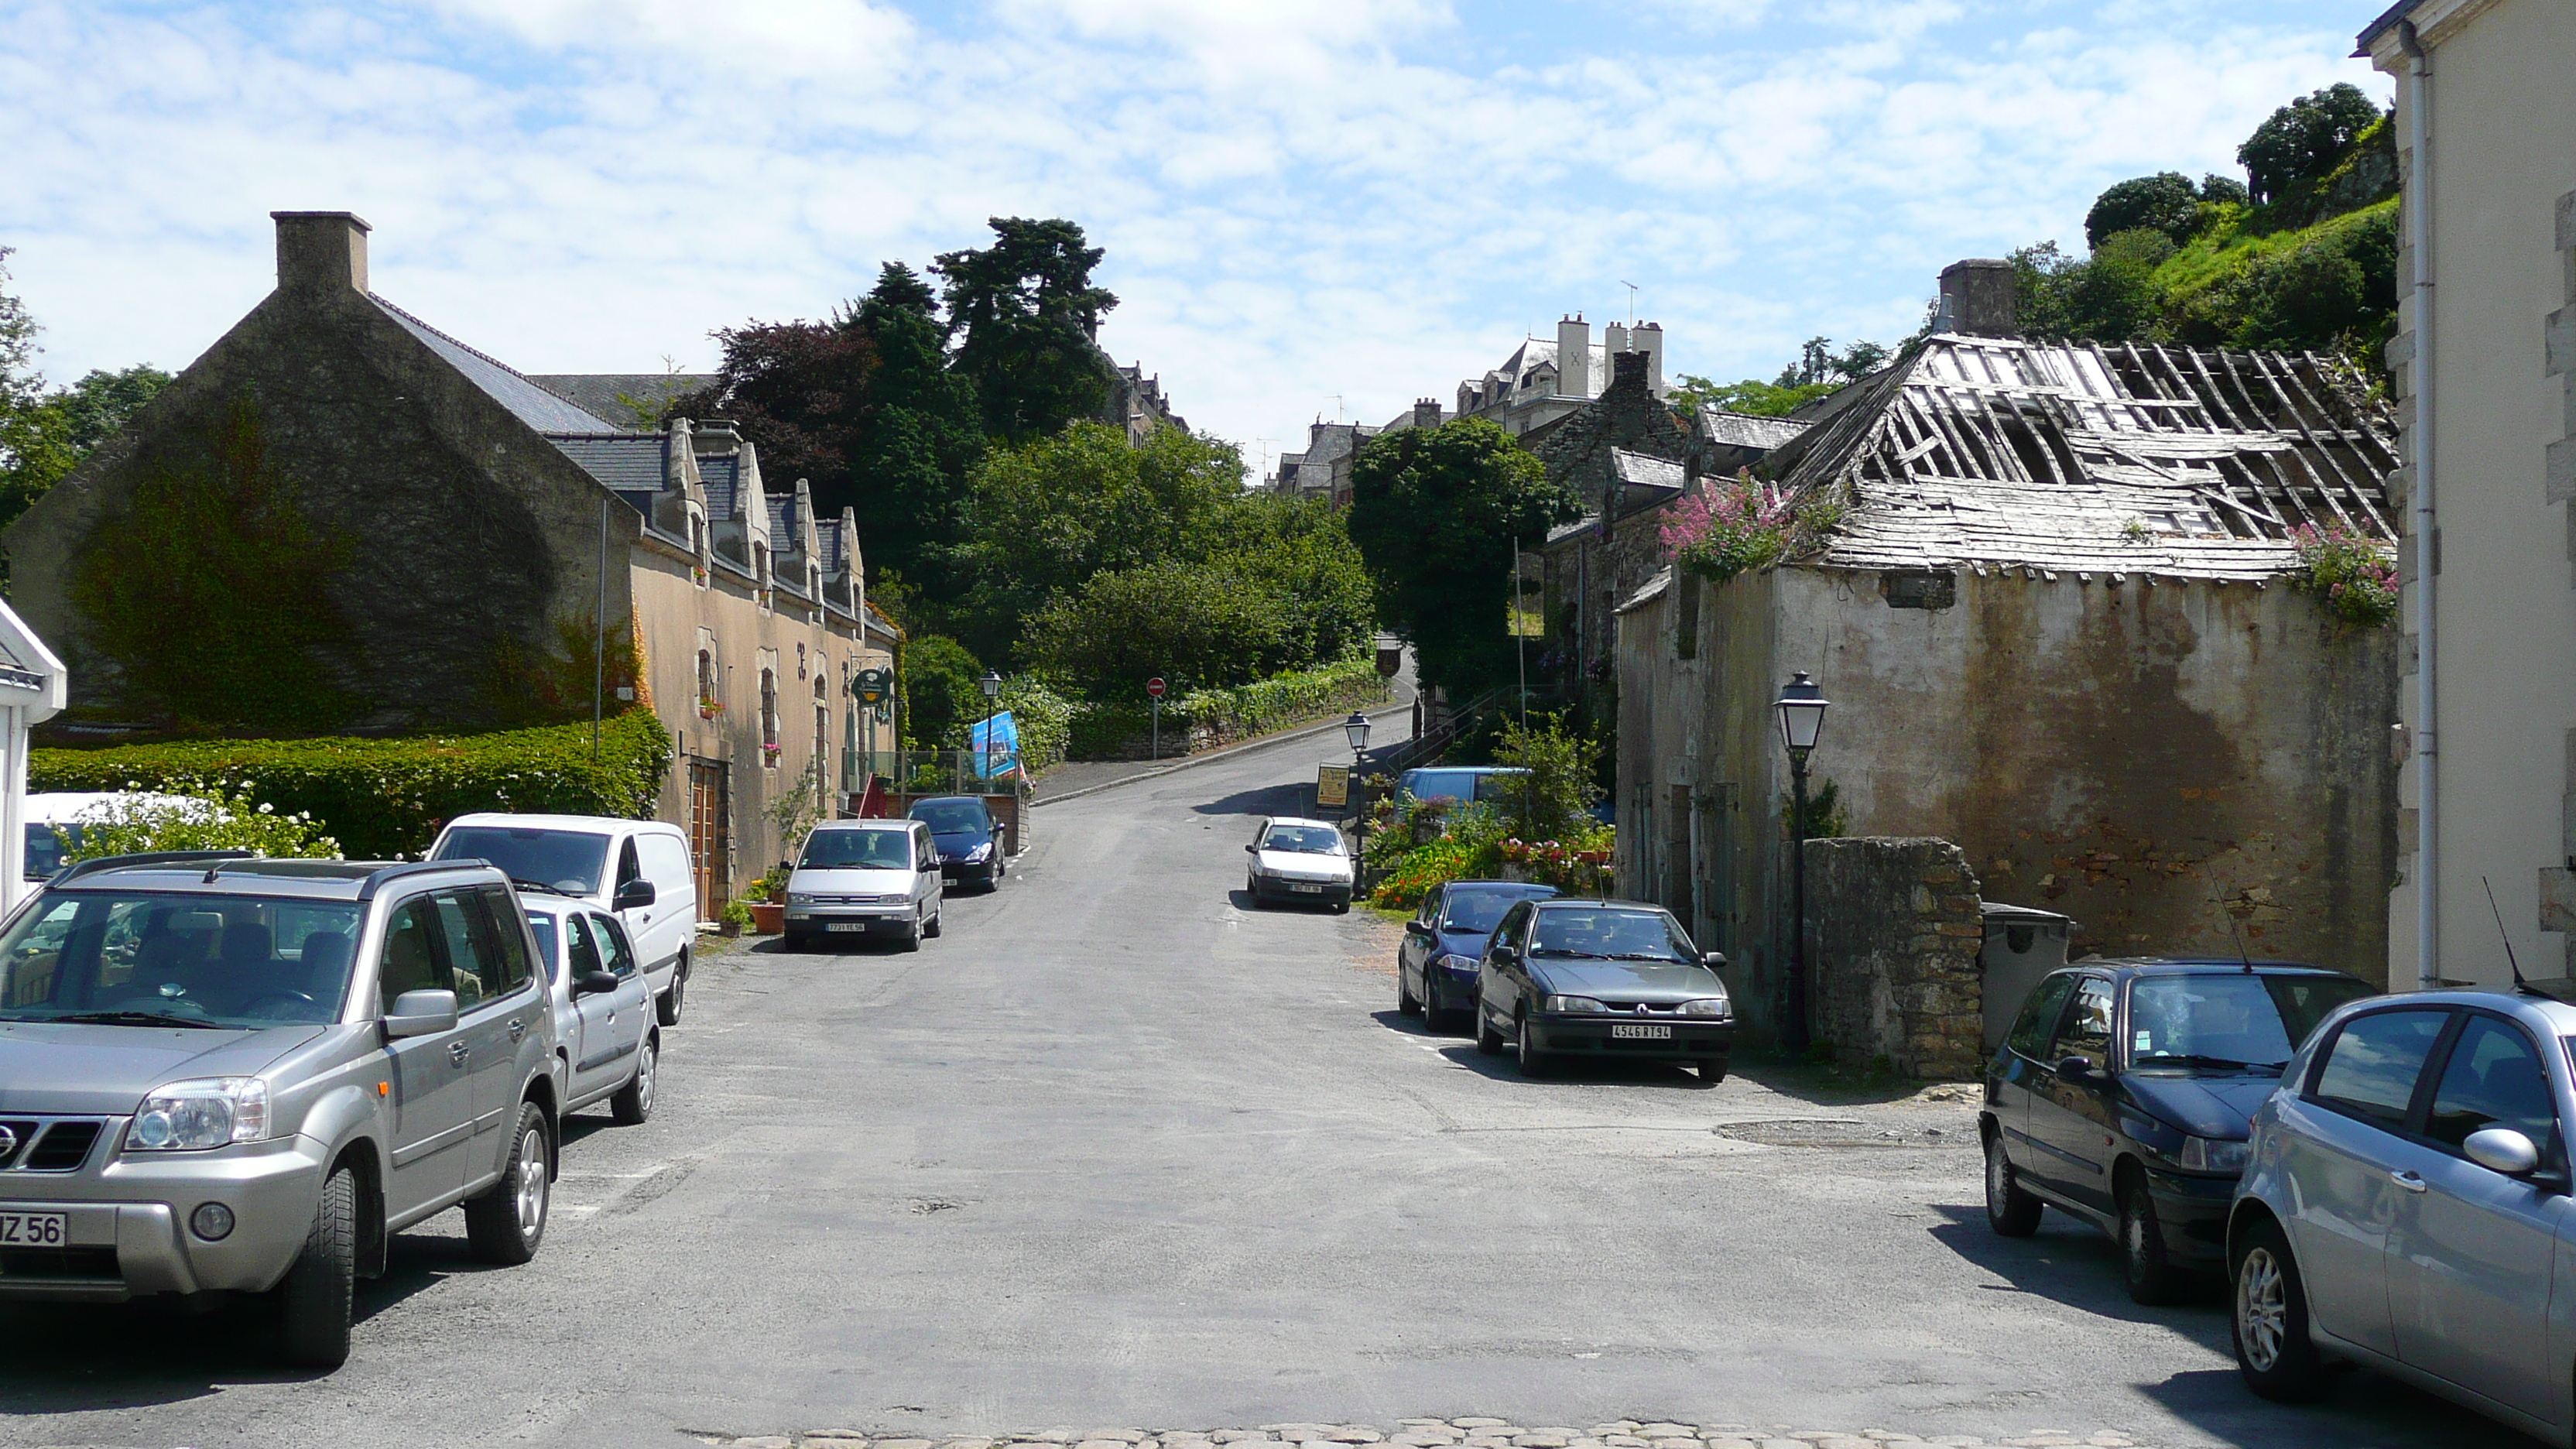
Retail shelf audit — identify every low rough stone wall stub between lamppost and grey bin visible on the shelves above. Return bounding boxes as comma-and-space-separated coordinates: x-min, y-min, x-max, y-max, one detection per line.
1806, 835, 1986, 1081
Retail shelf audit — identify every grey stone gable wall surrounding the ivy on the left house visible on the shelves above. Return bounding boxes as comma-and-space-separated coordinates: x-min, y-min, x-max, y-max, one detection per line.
0, 242, 636, 732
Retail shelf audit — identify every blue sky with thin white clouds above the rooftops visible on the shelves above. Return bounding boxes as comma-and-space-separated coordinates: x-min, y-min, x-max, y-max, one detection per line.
0, 0, 2388, 474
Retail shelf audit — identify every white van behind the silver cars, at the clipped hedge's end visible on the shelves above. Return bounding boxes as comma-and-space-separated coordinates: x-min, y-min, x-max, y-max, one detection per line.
430, 815, 698, 1026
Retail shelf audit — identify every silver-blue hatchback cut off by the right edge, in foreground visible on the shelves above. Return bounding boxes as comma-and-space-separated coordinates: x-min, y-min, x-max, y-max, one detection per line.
2228, 975, 2576, 1444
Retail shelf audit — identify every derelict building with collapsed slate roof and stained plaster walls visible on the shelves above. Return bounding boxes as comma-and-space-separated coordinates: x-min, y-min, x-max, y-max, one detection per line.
1618, 263, 2398, 1036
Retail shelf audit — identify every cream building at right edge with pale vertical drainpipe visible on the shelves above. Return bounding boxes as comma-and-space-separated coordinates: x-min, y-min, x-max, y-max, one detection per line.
2359, 0, 2576, 985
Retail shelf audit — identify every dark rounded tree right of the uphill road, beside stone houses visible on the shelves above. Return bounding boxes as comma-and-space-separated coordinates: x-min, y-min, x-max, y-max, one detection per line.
1350, 418, 1581, 694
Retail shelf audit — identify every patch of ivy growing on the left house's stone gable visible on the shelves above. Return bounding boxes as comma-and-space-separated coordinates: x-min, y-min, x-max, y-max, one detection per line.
70, 392, 371, 732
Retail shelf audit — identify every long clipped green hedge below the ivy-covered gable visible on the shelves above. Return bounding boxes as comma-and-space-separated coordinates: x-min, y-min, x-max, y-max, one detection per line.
29, 709, 670, 862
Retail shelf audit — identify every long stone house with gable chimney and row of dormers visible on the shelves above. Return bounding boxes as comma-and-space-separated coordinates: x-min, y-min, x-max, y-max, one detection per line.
0, 211, 896, 907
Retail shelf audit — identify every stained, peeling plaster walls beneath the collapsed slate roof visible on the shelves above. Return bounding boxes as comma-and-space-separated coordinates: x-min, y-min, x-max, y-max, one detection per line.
1620, 559, 2396, 1021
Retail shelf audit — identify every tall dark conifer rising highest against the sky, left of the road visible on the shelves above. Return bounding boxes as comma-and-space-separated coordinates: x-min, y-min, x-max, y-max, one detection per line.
930, 217, 1118, 444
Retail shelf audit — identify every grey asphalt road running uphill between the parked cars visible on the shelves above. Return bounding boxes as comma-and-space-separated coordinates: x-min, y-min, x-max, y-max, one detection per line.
0, 738, 2516, 1449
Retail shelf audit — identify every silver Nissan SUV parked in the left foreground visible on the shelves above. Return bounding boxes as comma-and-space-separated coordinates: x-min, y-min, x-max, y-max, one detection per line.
0, 851, 557, 1366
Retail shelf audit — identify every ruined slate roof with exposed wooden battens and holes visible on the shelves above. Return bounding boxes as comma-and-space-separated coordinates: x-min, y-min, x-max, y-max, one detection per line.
1757, 335, 2398, 580
